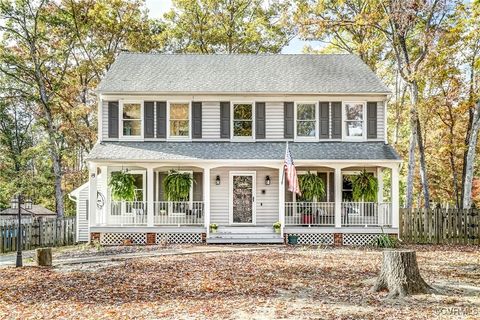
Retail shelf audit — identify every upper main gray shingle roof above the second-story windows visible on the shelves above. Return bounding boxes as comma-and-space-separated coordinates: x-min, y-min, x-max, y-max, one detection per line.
97, 53, 389, 94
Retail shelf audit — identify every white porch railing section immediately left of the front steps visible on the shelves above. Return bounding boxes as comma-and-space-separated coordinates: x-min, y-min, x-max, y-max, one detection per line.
153, 201, 205, 226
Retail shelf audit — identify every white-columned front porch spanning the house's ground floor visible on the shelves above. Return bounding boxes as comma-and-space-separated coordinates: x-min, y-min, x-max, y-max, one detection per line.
88, 161, 398, 243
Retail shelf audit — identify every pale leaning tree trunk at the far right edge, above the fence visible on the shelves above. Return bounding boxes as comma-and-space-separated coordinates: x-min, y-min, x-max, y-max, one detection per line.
462, 101, 480, 209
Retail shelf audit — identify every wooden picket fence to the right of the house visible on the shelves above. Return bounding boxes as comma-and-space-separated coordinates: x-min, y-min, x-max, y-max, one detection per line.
400, 208, 480, 245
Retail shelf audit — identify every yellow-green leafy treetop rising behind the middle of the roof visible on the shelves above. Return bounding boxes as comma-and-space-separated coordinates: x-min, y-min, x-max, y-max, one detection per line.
164, 0, 293, 53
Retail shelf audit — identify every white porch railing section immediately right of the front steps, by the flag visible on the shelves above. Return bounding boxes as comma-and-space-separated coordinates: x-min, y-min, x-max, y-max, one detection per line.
285, 202, 335, 226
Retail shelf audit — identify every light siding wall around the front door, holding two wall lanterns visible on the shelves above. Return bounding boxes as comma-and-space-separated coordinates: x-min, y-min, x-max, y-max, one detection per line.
210, 167, 279, 225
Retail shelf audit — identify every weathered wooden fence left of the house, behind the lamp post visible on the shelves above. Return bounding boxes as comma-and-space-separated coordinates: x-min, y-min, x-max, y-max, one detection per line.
0, 217, 77, 253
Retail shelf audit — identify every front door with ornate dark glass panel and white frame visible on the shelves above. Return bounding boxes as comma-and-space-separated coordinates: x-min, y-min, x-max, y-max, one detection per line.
230, 172, 256, 224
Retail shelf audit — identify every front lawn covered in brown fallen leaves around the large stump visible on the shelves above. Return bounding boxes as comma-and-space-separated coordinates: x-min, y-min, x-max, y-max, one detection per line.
0, 246, 480, 319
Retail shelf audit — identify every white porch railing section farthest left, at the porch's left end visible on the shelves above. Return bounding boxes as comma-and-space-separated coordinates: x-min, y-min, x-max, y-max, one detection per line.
107, 201, 147, 226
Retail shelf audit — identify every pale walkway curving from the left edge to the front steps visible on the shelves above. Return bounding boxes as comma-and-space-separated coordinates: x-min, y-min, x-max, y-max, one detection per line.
0, 245, 283, 268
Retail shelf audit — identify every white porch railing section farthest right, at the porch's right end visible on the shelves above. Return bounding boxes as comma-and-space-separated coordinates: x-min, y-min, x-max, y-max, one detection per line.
342, 202, 392, 227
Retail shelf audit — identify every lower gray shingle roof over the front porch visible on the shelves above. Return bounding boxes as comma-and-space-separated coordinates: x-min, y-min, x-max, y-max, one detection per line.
88, 141, 400, 161
